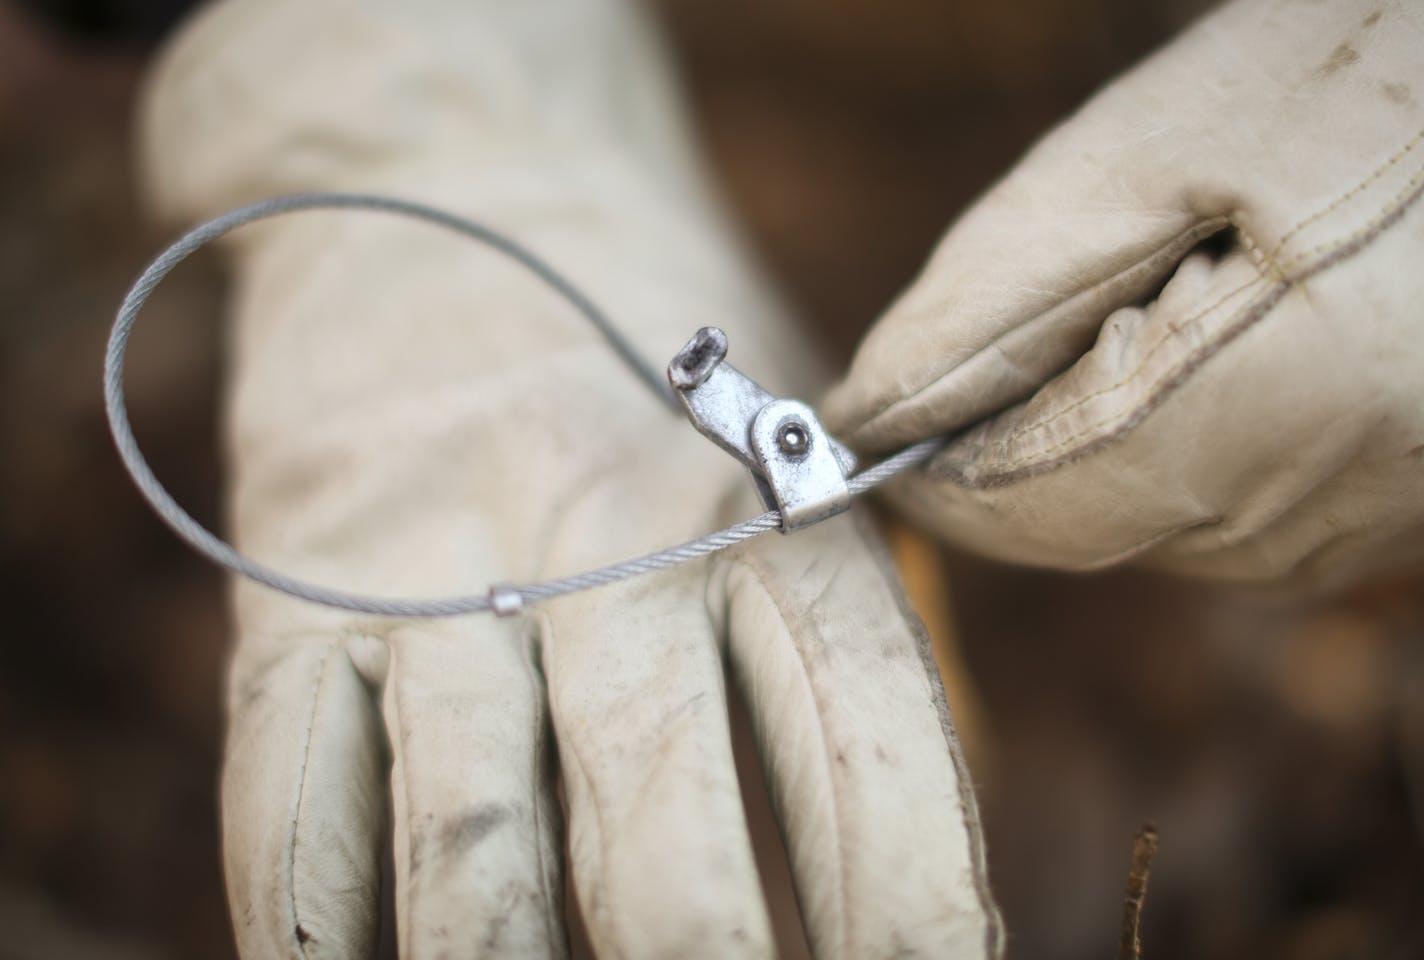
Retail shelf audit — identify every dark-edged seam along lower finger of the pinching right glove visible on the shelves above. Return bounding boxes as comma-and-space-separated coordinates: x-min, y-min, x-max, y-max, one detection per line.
941, 134, 1424, 489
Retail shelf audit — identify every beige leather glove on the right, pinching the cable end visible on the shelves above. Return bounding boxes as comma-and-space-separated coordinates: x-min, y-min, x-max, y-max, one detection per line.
823, 0, 1424, 580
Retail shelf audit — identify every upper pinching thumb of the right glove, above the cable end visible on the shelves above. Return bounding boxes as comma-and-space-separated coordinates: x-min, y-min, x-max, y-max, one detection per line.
822, 91, 1229, 452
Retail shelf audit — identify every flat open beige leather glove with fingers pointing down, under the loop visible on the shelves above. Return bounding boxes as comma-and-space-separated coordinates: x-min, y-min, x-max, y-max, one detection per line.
145, 0, 998, 957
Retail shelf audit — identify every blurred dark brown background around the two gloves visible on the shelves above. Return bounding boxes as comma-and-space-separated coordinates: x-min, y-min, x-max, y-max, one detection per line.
0, 0, 1424, 960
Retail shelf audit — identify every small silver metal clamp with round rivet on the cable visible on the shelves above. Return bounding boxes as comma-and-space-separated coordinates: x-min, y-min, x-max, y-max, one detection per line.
668, 326, 856, 533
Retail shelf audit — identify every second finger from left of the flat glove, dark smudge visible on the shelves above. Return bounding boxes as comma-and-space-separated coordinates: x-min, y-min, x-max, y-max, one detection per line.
384, 617, 567, 960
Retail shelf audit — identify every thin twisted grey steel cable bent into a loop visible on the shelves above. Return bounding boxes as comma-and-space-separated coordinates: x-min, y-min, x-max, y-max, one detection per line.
104, 194, 944, 617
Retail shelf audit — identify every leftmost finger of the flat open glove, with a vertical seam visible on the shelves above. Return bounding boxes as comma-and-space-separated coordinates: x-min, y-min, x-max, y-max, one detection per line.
222, 623, 386, 960
